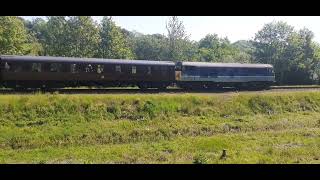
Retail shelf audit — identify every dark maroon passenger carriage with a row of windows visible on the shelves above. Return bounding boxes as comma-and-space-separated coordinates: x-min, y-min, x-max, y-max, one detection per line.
0, 56, 175, 88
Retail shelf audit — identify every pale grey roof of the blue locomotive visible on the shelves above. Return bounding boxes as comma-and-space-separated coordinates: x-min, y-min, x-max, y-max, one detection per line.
182, 62, 273, 68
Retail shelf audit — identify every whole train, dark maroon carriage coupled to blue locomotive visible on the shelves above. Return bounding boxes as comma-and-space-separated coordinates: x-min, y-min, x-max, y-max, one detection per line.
0, 55, 275, 89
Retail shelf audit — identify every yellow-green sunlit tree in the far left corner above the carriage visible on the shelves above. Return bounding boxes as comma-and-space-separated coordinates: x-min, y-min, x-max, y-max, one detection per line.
0, 16, 40, 55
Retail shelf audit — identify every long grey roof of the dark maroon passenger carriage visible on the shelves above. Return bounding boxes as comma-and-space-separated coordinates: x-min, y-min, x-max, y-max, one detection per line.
0, 55, 174, 66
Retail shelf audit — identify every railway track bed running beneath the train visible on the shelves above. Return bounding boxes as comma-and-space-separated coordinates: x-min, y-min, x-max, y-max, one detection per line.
0, 86, 320, 94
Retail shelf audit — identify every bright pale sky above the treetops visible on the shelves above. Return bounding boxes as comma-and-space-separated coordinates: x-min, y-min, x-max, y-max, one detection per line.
22, 16, 320, 43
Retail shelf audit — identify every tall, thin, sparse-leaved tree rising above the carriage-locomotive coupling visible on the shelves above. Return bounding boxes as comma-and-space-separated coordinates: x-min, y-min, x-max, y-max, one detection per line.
166, 16, 188, 61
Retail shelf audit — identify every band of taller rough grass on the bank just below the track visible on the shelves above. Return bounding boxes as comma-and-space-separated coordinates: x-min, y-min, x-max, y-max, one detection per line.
0, 93, 320, 122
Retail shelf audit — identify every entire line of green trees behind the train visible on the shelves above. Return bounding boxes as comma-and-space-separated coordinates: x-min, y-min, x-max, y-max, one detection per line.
0, 16, 320, 84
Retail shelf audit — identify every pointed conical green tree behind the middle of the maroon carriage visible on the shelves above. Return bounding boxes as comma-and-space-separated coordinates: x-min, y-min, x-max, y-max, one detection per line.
98, 17, 134, 59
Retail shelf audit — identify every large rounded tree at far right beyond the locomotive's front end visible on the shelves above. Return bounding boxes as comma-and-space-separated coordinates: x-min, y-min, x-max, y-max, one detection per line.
254, 22, 319, 84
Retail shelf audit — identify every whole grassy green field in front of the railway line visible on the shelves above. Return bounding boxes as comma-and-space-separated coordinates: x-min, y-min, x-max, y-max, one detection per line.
0, 92, 320, 163
